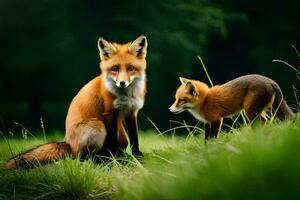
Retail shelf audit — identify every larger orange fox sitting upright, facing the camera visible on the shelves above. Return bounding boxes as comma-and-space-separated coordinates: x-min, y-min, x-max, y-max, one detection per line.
5, 36, 147, 169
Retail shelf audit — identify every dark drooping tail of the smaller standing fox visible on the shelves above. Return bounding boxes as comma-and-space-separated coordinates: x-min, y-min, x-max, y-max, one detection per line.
273, 83, 296, 121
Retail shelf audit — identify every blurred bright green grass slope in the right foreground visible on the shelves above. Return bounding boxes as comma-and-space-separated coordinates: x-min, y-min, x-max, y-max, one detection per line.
120, 123, 300, 199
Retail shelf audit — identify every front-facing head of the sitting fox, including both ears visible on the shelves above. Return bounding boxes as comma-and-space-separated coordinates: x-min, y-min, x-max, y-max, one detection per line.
98, 36, 147, 88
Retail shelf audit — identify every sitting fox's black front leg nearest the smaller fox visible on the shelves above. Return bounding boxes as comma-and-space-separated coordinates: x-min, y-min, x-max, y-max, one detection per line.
125, 112, 143, 156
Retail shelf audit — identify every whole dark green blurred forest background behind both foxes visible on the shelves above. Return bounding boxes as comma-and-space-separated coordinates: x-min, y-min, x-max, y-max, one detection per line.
0, 0, 300, 132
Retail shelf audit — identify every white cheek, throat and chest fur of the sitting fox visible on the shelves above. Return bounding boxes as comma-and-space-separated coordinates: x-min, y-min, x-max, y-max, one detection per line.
105, 74, 145, 114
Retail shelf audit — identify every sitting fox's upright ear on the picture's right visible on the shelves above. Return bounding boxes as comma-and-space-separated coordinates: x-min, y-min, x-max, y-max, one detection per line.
128, 35, 148, 58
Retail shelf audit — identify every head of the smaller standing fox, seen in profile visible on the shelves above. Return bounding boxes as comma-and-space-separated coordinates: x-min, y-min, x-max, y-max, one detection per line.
169, 77, 199, 114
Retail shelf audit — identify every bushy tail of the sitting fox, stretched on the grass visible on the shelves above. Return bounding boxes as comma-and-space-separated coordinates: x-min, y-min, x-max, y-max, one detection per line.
5, 142, 71, 169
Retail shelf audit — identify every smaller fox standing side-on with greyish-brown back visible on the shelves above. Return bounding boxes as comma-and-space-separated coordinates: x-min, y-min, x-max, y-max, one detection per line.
170, 74, 295, 141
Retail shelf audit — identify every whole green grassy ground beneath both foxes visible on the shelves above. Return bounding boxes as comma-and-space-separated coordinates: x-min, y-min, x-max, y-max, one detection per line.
0, 119, 300, 200
